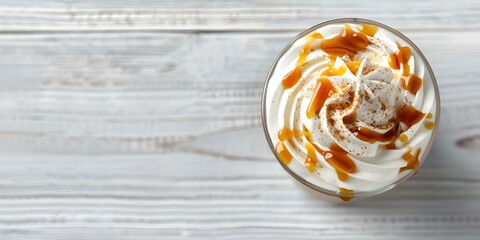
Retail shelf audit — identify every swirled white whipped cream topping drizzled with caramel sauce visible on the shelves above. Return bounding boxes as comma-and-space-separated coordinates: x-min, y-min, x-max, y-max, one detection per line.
266, 24, 437, 201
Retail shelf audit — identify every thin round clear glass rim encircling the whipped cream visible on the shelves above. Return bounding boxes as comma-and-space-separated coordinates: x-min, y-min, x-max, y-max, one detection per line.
261, 18, 441, 198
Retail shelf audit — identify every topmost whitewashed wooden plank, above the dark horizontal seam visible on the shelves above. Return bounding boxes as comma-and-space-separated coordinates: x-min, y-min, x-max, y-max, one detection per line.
0, 0, 480, 31
